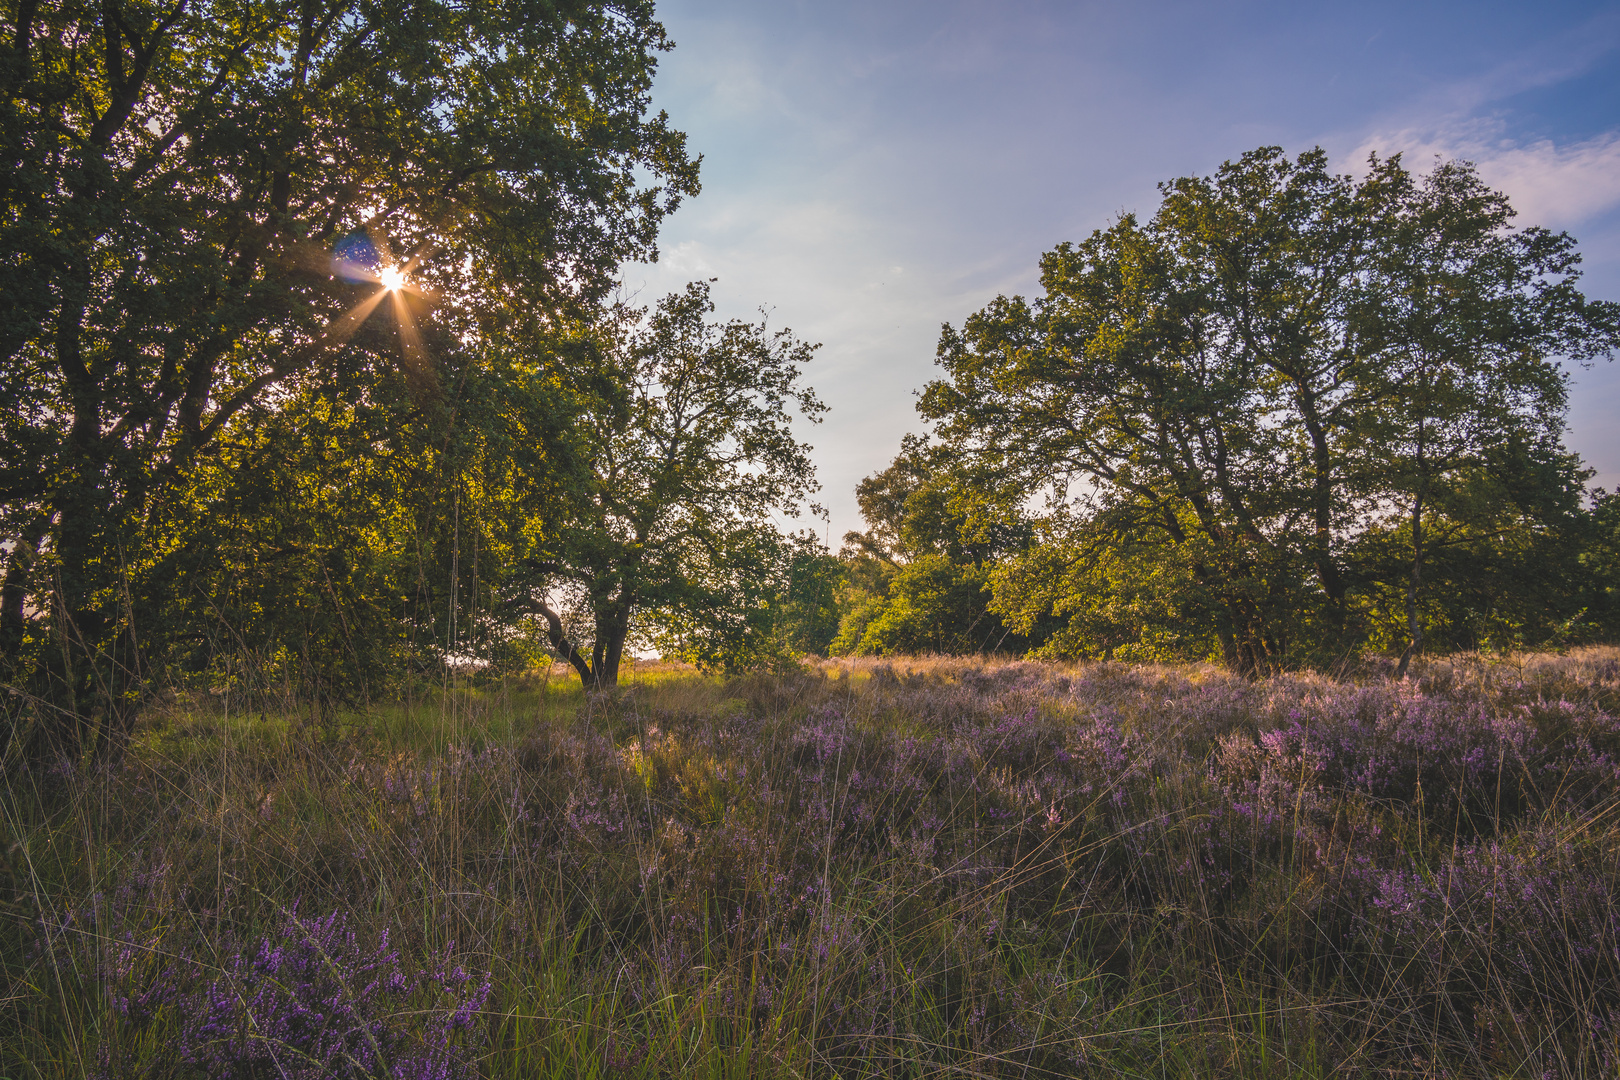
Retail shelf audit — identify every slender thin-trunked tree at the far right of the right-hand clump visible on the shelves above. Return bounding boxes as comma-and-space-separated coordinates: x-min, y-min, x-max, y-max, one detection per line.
1351, 160, 1615, 675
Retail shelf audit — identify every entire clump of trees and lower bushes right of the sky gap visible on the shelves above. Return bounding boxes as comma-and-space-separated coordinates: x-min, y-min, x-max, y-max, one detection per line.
833, 147, 1620, 674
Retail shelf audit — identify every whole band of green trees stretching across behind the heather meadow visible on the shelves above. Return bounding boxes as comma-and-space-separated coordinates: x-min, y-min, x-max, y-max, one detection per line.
0, 3, 1620, 761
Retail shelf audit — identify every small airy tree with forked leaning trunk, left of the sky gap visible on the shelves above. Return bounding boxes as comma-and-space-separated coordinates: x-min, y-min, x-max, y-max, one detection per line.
505, 282, 825, 687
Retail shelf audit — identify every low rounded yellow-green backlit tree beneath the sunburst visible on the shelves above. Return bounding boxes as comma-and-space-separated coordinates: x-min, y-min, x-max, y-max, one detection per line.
133, 335, 565, 717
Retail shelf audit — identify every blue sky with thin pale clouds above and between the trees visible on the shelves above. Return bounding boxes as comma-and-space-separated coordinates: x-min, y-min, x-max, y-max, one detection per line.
624, 0, 1620, 549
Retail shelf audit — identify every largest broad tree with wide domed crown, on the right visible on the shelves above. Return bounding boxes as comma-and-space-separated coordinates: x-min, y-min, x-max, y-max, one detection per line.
920, 149, 1620, 672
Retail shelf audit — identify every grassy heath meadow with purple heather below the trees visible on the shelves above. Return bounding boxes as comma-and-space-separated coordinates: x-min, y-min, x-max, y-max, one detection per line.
0, 648, 1620, 1080
